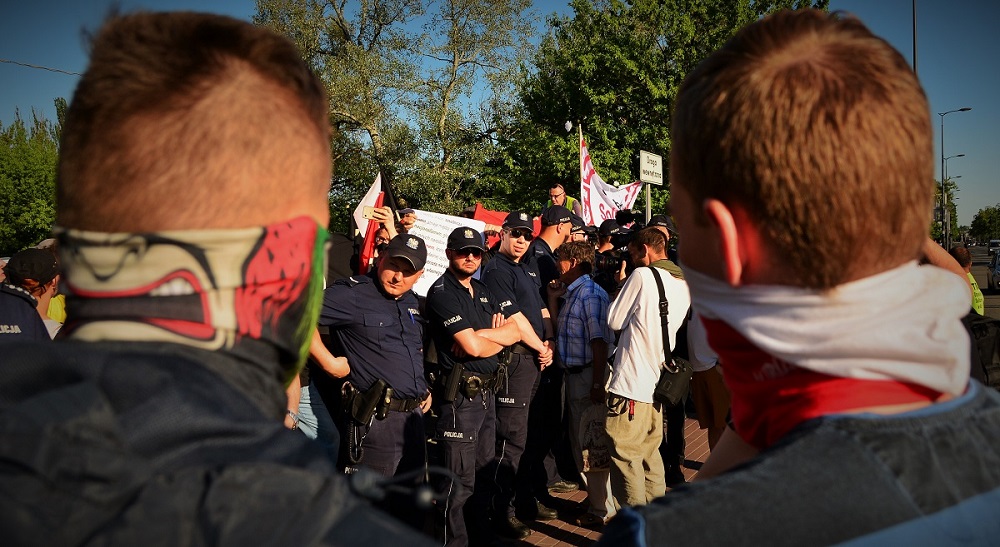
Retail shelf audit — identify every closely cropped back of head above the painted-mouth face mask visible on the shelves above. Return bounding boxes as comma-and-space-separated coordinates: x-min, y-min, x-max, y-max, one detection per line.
57, 12, 330, 231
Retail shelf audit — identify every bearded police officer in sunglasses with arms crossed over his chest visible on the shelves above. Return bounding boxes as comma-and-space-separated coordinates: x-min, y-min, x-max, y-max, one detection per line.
426, 227, 520, 545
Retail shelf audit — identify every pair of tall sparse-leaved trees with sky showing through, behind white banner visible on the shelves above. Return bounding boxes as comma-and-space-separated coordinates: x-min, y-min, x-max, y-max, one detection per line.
254, 0, 532, 231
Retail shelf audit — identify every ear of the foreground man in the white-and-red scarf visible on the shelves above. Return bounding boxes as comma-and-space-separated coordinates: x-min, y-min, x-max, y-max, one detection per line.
703, 199, 763, 287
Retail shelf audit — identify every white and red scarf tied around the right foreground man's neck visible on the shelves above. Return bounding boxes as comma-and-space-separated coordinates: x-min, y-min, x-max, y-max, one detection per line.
684, 262, 970, 448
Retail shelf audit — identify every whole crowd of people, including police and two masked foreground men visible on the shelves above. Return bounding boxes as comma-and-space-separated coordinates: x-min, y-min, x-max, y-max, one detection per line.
0, 10, 1000, 546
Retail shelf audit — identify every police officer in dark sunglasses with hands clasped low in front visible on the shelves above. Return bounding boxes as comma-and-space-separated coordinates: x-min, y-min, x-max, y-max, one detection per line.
483, 211, 553, 539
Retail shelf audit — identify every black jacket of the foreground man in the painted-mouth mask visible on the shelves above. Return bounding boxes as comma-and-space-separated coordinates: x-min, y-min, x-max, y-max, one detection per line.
0, 341, 429, 547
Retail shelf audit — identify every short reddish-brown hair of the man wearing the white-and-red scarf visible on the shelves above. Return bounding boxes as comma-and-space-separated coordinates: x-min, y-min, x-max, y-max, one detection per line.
670, 10, 934, 289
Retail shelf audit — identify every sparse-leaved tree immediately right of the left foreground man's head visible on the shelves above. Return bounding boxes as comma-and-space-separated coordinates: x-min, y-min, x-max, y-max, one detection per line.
253, 0, 423, 232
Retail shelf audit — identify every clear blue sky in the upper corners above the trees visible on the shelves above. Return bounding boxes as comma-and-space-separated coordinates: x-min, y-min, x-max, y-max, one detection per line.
0, 0, 1000, 224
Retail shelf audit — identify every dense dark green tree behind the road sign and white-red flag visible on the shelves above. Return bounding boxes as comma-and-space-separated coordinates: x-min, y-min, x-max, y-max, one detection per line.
497, 0, 828, 217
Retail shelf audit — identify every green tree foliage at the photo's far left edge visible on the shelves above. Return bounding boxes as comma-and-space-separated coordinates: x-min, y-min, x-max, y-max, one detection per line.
0, 108, 60, 256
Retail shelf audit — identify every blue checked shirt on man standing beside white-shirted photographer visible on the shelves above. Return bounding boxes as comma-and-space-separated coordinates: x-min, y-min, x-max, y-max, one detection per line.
556, 275, 615, 368
